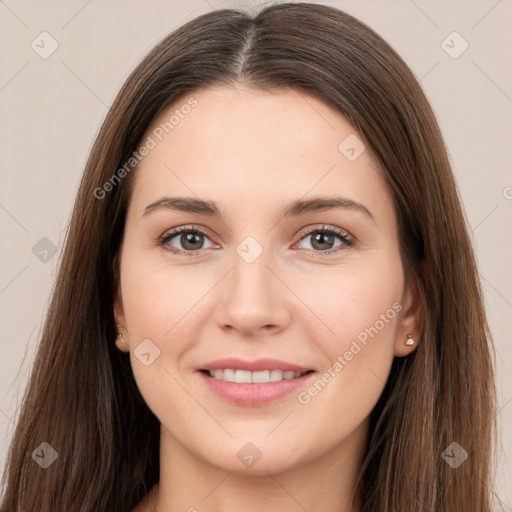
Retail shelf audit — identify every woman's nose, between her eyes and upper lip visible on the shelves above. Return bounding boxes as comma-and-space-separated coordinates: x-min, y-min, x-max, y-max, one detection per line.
215, 252, 293, 337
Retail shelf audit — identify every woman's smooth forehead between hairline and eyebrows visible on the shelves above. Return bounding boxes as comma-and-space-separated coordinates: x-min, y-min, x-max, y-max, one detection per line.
127, 86, 390, 224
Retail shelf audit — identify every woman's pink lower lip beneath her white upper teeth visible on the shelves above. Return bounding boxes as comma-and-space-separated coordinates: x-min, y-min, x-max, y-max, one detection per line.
198, 371, 315, 406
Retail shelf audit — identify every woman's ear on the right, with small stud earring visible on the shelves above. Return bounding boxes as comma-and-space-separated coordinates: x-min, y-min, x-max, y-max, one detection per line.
394, 274, 424, 357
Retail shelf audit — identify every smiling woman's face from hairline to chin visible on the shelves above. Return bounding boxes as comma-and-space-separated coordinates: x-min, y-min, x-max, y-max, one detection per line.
115, 86, 418, 473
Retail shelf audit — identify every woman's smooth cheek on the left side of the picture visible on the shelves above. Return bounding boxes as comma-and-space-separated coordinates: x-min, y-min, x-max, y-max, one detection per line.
121, 250, 226, 423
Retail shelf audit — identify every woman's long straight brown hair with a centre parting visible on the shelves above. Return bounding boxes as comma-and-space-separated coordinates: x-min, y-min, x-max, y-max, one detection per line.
2, 3, 495, 512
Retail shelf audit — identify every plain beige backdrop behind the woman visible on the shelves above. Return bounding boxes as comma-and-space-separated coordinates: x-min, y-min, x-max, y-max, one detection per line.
0, 0, 512, 509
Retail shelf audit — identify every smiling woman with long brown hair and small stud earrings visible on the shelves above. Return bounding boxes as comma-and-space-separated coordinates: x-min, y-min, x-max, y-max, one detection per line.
2, 3, 495, 512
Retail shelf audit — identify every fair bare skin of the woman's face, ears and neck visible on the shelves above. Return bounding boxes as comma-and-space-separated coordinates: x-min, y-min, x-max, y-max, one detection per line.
115, 85, 421, 512
